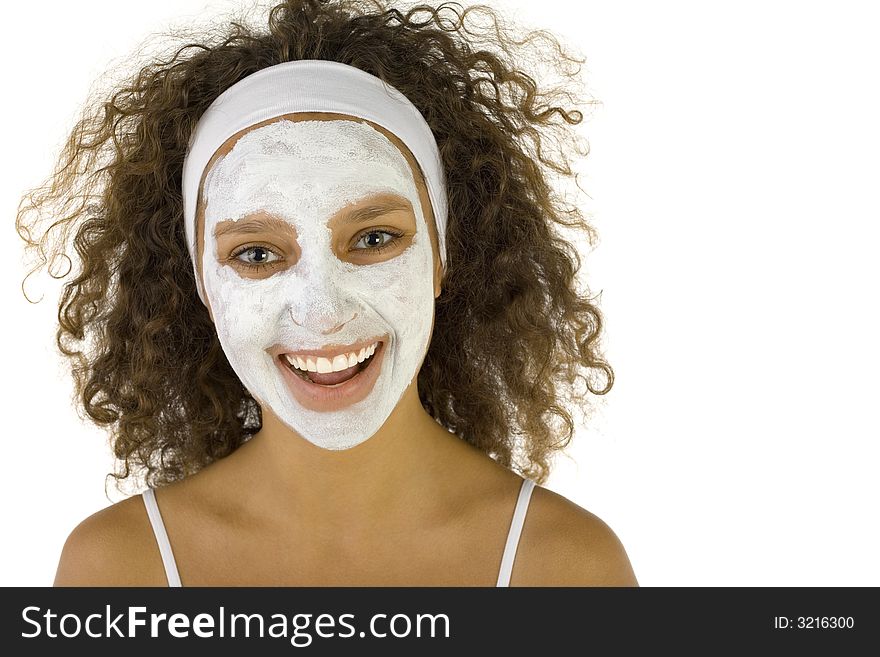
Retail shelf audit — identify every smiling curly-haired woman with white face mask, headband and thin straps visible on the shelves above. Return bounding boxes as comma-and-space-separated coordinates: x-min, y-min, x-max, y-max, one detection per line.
18, 0, 637, 586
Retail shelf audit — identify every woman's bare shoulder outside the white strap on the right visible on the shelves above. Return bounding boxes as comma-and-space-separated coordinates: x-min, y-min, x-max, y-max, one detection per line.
511, 486, 638, 586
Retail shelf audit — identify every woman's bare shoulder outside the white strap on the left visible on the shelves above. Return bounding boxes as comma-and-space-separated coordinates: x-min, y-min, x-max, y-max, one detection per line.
54, 495, 165, 586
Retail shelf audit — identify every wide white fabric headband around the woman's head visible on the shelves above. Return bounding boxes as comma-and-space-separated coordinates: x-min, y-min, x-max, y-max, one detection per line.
182, 59, 447, 303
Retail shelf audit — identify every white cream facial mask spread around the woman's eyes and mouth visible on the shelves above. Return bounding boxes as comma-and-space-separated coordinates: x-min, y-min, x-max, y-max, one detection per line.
202, 120, 434, 450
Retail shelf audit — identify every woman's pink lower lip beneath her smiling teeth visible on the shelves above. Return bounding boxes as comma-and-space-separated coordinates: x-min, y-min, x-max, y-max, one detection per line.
273, 336, 388, 412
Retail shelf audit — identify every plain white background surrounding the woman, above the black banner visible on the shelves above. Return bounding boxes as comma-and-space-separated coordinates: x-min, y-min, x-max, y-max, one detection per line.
0, 0, 880, 586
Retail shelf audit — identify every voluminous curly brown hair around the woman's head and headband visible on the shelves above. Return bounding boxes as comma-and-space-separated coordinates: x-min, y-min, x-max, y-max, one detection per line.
16, 0, 614, 486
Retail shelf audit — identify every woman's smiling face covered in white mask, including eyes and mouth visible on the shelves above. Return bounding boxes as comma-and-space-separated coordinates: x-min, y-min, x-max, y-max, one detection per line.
193, 116, 439, 449
